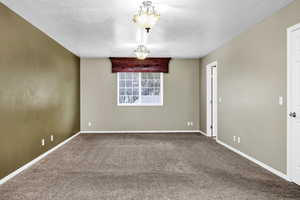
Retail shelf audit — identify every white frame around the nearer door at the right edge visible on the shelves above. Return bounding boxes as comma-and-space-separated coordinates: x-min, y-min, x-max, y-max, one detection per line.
286, 23, 300, 181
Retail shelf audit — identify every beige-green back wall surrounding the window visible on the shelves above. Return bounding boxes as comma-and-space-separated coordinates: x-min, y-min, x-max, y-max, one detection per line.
81, 59, 200, 131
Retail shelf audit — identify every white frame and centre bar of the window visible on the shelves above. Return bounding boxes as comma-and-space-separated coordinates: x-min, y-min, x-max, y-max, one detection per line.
117, 72, 164, 107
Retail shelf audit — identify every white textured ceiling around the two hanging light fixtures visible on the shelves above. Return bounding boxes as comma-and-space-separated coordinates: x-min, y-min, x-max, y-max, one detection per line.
0, 0, 293, 58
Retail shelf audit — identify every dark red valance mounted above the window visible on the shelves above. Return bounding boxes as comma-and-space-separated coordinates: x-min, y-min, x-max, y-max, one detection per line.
110, 58, 171, 73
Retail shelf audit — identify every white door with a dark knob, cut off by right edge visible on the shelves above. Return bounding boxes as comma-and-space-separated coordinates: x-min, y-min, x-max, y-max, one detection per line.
288, 26, 300, 185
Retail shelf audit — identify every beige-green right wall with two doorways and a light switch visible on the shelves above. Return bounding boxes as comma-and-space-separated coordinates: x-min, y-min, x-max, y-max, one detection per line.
200, 1, 300, 173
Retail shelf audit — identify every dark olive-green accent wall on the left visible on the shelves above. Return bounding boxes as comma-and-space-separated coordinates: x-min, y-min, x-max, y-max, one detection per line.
0, 3, 80, 179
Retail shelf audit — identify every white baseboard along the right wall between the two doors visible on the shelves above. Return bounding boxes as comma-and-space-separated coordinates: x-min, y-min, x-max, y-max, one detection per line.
217, 140, 291, 182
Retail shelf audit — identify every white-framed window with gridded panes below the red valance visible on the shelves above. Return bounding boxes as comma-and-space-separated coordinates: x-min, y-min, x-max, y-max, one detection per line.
118, 72, 163, 106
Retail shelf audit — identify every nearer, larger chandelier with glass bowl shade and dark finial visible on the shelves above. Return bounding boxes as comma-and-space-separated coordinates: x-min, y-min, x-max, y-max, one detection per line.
133, 1, 160, 32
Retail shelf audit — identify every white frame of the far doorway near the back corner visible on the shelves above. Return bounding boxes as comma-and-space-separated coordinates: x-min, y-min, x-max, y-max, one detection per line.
206, 61, 218, 138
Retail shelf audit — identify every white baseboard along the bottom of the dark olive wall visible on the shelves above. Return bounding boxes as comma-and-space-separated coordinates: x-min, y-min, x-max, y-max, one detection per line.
0, 132, 80, 185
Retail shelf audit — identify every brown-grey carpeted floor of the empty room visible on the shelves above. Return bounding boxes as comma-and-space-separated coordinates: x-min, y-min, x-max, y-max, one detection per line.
0, 133, 300, 200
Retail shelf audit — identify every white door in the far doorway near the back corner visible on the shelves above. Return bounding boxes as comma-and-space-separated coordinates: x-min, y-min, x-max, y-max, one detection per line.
206, 62, 218, 137
